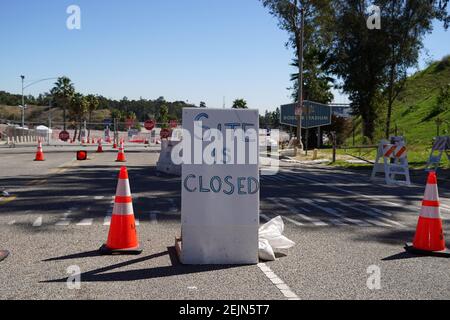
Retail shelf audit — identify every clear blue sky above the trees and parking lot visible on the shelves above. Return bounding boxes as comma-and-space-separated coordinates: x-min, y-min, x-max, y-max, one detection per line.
0, 0, 450, 111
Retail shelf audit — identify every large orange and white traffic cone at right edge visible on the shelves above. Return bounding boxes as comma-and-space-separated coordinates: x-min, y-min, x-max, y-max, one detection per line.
405, 171, 450, 256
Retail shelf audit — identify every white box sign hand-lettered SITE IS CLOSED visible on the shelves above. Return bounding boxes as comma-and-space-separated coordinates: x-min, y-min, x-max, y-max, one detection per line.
181, 108, 259, 265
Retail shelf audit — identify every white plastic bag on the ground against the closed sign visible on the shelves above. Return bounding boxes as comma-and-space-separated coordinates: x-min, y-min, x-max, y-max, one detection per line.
259, 216, 295, 261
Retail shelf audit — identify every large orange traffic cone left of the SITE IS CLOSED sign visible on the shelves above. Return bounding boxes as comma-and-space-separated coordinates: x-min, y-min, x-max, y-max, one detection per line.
100, 167, 142, 255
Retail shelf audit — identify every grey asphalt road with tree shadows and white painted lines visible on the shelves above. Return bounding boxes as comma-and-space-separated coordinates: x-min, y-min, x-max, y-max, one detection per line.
0, 147, 450, 300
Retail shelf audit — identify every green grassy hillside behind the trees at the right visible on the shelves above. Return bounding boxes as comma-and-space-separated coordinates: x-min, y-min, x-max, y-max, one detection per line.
340, 56, 450, 168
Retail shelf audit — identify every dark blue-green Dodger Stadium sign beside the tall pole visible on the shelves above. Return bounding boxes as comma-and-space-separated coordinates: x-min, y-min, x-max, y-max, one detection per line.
280, 101, 331, 129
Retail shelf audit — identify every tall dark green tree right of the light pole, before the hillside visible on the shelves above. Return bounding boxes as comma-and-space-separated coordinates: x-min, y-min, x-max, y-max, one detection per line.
328, 0, 450, 141
